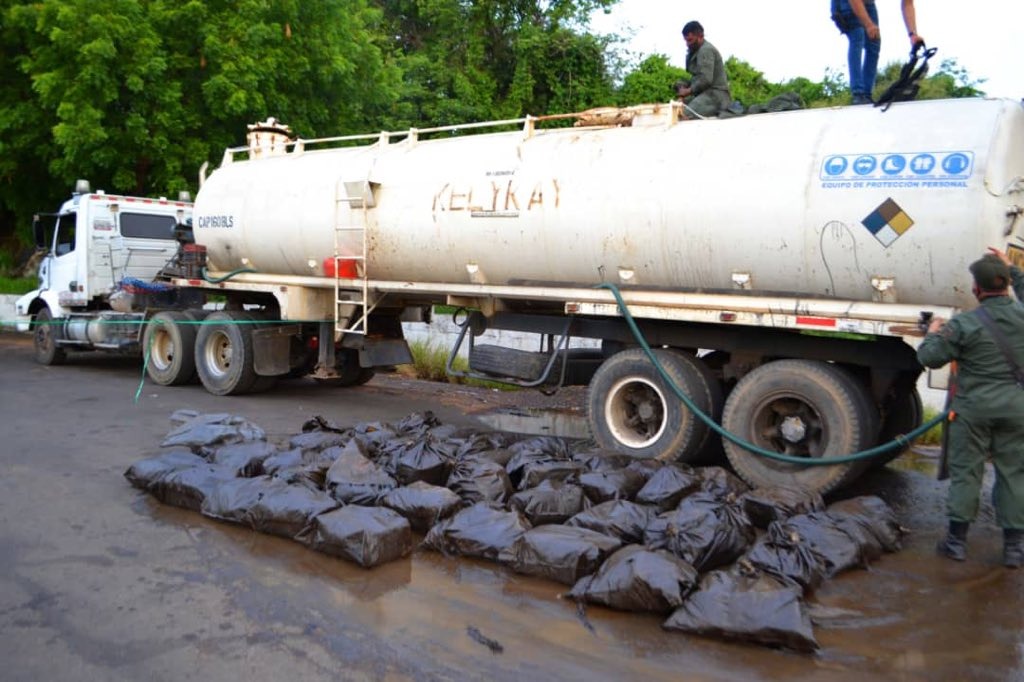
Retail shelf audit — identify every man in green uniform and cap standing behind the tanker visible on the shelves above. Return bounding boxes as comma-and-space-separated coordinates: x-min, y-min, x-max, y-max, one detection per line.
918, 249, 1024, 568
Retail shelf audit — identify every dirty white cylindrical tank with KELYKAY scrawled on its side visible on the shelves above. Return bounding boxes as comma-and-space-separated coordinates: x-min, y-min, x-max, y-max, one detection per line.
195, 99, 1024, 306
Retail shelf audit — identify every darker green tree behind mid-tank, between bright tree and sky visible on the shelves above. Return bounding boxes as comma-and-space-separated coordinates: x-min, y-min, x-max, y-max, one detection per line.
382, 0, 616, 127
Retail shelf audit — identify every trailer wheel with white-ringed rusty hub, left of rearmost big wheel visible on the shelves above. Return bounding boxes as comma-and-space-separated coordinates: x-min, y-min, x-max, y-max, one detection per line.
587, 348, 712, 462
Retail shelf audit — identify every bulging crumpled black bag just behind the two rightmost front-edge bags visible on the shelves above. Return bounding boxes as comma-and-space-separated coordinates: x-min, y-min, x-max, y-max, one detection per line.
644, 493, 756, 573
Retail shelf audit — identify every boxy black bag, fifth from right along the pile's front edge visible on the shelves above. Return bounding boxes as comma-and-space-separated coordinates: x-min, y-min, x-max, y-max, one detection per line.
297, 505, 413, 568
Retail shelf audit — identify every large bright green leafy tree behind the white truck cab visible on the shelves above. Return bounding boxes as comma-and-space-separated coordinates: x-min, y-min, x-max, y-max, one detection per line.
0, 0, 398, 249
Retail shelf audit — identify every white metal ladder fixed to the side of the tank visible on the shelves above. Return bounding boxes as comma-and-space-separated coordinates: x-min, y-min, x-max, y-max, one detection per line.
334, 179, 374, 335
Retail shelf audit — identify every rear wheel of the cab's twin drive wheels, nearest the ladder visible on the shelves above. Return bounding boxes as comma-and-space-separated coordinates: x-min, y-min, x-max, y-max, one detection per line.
196, 310, 256, 395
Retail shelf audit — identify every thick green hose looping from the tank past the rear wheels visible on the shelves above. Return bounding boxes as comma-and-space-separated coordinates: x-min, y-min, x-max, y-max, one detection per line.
596, 283, 949, 466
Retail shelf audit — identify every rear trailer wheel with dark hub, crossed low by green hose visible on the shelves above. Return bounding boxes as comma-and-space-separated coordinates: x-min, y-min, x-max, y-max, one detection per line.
722, 359, 878, 494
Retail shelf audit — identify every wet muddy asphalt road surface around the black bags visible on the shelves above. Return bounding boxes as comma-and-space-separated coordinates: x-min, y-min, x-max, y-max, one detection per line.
0, 333, 1024, 681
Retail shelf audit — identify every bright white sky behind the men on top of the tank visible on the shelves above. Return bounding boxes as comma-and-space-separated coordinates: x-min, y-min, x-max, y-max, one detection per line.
591, 0, 1024, 99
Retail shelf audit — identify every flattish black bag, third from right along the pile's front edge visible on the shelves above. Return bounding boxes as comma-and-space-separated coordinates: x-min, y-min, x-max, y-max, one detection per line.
498, 525, 623, 585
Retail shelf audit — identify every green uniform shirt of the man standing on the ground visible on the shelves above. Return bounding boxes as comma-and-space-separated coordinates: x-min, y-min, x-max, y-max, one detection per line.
918, 267, 1024, 417
